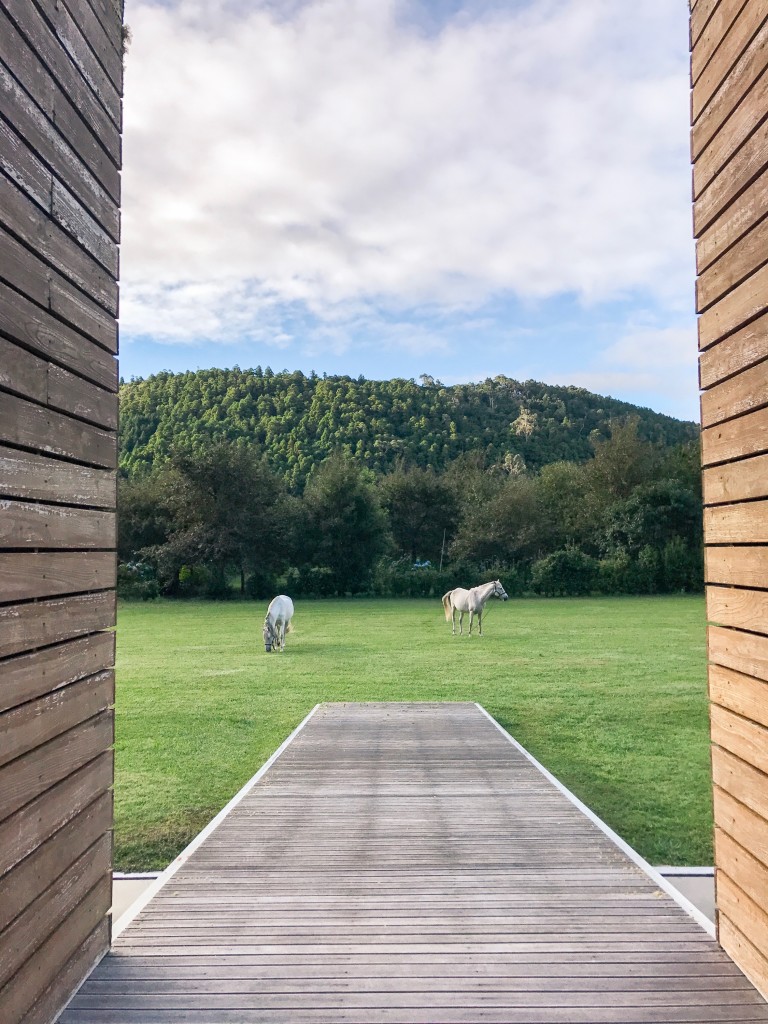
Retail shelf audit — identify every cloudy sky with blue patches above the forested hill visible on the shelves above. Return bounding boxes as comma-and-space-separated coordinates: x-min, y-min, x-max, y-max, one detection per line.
121, 0, 698, 419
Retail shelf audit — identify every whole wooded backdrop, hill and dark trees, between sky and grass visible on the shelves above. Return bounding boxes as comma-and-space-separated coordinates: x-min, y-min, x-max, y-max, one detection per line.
120, 370, 702, 598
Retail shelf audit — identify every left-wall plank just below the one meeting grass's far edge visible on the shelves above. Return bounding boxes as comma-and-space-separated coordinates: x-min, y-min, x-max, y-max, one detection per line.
0, 633, 115, 711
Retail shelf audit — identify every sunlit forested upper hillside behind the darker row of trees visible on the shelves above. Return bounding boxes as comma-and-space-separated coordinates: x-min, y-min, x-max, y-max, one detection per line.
120, 368, 698, 487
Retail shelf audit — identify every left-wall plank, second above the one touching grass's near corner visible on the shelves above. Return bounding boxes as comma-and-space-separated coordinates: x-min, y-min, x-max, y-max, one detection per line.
0, 751, 114, 876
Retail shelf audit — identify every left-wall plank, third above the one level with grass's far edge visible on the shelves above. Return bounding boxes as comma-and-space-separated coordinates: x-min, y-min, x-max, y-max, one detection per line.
0, 444, 117, 509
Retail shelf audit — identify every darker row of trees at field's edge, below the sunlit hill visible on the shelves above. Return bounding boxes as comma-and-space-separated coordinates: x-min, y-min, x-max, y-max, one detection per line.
120, 420, 702, 598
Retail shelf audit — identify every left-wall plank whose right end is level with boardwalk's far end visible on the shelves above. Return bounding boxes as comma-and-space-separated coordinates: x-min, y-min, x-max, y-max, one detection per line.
0, 670, 115, 766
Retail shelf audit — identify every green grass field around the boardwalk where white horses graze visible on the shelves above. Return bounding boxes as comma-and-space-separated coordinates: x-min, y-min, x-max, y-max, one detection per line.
116, 596, 712, 870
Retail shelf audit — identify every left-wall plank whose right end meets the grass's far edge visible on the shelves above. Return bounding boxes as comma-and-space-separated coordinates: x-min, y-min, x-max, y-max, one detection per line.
0, 591, 115, 657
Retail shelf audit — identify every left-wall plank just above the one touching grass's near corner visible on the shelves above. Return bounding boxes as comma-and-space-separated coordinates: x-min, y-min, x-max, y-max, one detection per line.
0, 793, 113, 932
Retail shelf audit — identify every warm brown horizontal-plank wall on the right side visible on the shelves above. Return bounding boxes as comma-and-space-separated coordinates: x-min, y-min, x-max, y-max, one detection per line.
691, 0, 768, 994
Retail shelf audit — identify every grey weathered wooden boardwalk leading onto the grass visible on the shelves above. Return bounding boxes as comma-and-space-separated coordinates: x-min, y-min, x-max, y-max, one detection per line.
60, 703, 768, 1024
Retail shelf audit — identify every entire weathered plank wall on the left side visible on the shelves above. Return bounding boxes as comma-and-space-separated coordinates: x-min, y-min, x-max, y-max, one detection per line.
0, 0, 123, 1024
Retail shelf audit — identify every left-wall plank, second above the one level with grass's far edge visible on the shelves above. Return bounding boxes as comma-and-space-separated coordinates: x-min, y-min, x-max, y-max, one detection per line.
0, 499, 117, 550
